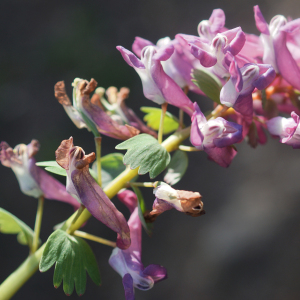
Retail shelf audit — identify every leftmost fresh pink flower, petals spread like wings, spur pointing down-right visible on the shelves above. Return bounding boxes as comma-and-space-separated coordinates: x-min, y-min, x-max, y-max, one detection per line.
117, 45, 193, 115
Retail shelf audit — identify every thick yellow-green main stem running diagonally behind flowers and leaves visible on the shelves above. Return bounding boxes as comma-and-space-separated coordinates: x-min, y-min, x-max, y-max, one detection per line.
0, 127, 190, 300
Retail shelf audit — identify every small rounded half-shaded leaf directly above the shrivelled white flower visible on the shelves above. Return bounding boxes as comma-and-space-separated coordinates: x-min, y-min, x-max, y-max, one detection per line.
164, 150, 189, 185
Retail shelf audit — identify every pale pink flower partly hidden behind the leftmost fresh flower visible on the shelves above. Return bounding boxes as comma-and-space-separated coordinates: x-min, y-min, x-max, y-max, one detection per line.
132, 37, 202, 94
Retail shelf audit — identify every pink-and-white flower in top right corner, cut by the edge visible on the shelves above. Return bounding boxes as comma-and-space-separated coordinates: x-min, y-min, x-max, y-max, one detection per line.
254, 5, 300, 89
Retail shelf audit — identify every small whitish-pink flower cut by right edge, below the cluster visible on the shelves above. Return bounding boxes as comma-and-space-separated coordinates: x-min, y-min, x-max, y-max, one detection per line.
267, 111, 300, 149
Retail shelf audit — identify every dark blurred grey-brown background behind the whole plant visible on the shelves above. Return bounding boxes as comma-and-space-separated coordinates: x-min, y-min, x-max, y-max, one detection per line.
0, 0, 300, 300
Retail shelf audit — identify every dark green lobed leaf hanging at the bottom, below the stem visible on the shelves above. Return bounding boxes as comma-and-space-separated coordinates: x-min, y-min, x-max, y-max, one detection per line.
40, 229, 101, 295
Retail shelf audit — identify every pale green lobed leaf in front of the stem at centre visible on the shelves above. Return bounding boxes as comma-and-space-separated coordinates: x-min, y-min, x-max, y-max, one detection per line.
116, 133, 170, 178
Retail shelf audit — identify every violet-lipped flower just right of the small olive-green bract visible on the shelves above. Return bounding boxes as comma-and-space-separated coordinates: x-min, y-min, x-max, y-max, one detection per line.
220, 61, 276, 118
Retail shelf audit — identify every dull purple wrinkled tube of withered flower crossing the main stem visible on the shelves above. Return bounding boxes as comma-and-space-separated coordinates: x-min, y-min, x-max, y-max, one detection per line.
71, 168, 130, 249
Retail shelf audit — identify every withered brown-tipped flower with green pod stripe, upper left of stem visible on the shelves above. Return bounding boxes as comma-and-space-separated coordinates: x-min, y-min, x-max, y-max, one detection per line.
54, 78, 139, 140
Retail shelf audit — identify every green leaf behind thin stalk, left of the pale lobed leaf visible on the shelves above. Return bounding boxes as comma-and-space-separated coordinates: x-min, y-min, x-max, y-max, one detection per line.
90, 153, 126, 187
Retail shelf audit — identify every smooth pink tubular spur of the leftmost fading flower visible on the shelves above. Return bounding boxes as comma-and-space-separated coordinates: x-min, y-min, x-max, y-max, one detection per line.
29, 158, 80, 209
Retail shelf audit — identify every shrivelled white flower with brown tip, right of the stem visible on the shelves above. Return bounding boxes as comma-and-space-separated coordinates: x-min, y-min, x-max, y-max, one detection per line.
146, 182, 205, 222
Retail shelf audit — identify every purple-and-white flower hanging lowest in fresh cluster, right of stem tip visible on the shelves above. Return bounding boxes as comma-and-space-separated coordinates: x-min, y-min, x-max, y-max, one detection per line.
190, 103, 243, 167
